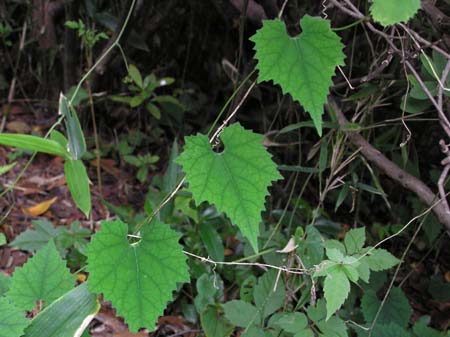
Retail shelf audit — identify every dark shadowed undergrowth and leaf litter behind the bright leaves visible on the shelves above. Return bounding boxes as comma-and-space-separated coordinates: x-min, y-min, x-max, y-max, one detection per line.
0, 0, 450, 329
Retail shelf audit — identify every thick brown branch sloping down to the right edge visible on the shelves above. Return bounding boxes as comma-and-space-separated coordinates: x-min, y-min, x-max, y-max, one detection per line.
328, 96, 450, 230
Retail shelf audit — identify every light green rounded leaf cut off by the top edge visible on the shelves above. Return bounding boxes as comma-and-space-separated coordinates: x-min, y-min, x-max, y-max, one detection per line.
370, 0, 420, 26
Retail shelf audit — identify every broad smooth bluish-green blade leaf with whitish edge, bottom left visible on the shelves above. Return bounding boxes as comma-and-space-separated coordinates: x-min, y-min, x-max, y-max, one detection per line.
24, 283, 100, 337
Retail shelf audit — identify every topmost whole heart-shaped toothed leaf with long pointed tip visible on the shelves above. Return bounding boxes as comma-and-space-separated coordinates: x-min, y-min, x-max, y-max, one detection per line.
250, 15, 345, 135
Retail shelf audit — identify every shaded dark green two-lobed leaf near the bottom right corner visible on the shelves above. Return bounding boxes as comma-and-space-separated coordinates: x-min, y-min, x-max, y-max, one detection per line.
361, 288, 412, 328
